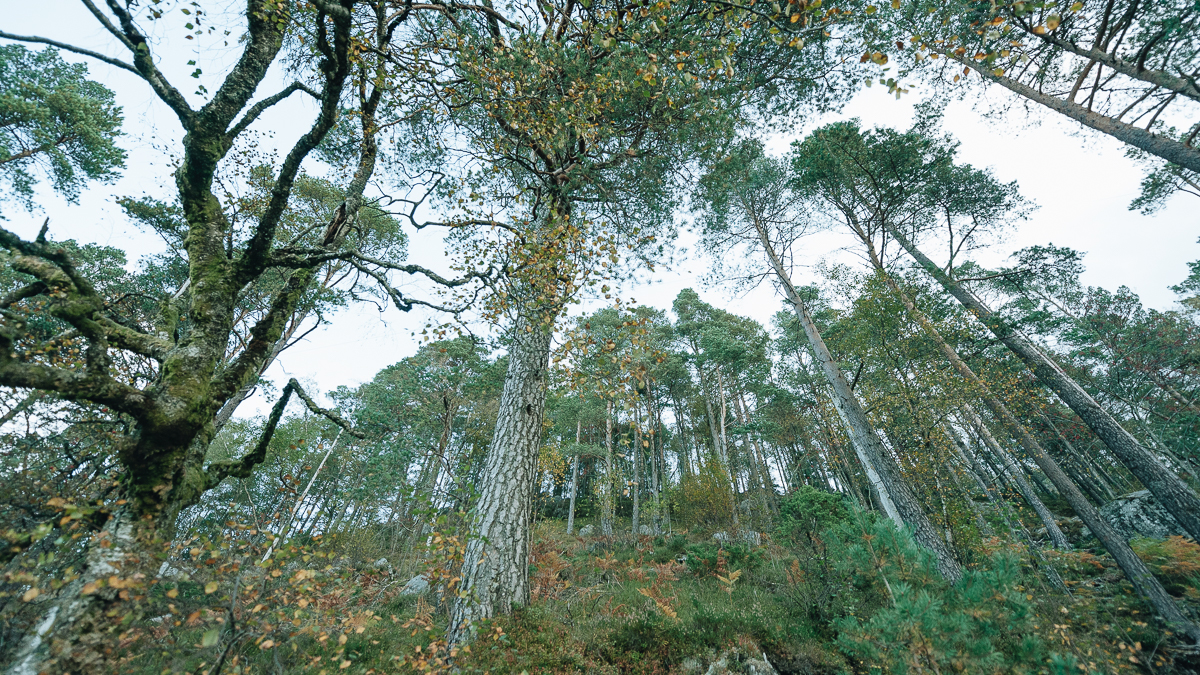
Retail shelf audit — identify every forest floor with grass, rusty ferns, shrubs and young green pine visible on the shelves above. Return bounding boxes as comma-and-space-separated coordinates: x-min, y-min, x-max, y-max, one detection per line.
112, 504, 1200, 675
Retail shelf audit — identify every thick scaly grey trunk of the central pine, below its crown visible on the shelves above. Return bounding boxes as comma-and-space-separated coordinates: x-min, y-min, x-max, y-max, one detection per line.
448, 315, 551, 644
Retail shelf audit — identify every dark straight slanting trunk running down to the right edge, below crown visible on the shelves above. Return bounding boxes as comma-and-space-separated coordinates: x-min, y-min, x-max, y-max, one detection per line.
888, 227, 1200, 539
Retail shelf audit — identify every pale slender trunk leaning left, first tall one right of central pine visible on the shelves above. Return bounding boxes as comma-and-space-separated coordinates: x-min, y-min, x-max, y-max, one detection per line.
756, 223, 962, 581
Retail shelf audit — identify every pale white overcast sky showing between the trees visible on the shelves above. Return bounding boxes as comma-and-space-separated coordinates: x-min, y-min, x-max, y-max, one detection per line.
0, 0, 1200, 414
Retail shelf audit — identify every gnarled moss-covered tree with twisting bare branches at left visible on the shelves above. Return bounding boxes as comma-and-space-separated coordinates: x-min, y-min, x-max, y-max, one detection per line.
0, 0, 353, 671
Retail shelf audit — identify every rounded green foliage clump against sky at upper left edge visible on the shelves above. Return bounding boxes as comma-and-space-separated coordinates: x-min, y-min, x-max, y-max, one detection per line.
0, 44, 125, 207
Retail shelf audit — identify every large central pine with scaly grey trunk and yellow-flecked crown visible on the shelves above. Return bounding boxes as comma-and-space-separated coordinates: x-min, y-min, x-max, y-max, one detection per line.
417, 0, 859, 643
